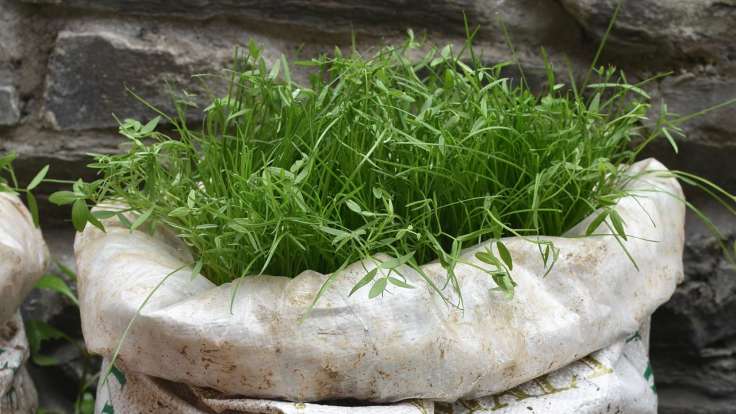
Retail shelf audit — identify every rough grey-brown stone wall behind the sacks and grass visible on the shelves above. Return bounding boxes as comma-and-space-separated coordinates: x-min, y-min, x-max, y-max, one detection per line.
0, 0, 736, 413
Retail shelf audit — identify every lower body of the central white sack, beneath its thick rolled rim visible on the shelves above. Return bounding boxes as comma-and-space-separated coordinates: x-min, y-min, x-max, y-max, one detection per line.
95, 323, 657, 414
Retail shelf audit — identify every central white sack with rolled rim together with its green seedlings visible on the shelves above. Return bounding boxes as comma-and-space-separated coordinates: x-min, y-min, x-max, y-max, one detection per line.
52, 29, 734, 412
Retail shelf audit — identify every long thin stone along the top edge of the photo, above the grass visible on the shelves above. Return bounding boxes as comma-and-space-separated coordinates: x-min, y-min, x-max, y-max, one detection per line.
24, 0, 579, 46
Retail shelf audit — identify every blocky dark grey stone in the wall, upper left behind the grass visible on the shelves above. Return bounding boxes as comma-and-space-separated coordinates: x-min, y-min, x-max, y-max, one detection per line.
45, 21, 236, 129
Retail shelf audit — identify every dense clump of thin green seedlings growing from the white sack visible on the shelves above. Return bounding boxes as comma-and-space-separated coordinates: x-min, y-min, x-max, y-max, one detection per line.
52, 36, 736, 304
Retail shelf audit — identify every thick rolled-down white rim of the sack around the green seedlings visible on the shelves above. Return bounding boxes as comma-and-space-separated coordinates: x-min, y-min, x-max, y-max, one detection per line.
75, 160, 685, 403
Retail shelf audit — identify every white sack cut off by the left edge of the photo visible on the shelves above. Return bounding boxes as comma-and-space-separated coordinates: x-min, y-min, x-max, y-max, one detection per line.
0, 192, 48, 414
